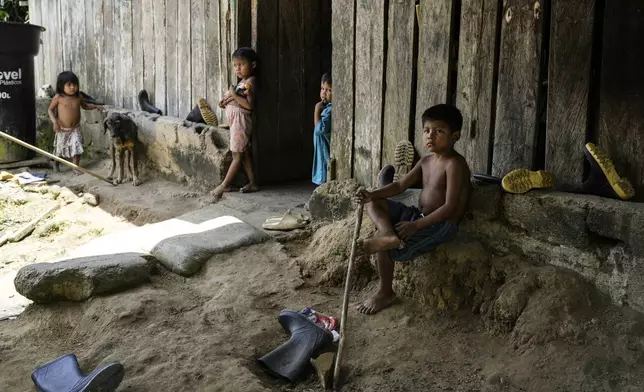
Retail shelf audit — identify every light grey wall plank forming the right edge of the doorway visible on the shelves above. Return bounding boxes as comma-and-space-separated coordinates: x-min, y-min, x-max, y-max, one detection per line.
331, 0, 355, 180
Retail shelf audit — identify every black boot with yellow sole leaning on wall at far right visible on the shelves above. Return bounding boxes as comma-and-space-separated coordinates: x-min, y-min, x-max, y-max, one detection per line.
581, 143, 635, 200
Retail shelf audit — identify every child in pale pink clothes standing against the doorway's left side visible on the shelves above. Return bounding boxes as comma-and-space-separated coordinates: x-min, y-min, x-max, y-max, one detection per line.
213, 48, 259, 198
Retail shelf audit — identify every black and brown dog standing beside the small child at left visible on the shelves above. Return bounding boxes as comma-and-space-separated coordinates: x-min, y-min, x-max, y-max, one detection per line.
103, 113, 141, 186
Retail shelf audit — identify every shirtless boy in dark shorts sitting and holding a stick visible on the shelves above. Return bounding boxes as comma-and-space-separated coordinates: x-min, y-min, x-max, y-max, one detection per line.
356, 105, 471, 314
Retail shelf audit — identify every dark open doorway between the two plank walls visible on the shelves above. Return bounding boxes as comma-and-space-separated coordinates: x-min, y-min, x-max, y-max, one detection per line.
251, 0, 331, 184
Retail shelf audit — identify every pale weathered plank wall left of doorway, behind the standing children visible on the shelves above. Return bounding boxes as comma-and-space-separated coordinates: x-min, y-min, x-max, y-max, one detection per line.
29, 0, 245, 120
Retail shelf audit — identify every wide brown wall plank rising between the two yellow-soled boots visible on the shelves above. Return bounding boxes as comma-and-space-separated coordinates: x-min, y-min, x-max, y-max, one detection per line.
546, 0, 595, 185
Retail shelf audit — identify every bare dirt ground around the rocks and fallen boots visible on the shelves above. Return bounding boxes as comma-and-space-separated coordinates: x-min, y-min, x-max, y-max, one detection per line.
0, 160, 644, 392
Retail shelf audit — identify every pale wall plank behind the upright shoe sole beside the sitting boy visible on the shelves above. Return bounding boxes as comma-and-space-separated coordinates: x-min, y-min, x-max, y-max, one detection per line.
382, 0, 416, 166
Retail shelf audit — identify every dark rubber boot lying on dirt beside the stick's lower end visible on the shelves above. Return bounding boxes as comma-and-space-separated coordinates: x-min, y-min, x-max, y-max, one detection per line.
258, 310, 333, 382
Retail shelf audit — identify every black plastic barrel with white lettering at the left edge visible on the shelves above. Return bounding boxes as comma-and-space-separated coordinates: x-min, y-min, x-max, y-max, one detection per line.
0, 22, 45, 163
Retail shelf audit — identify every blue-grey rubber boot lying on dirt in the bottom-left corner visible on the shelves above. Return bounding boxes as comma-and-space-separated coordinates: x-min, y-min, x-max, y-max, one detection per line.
31, 354, 125, 392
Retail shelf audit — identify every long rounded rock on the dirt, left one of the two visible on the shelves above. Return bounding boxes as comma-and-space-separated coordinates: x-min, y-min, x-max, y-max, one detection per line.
14, 253, 150, 303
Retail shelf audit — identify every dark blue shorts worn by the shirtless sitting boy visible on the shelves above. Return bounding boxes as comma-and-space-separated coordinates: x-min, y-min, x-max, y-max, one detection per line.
387, 200, 458, 261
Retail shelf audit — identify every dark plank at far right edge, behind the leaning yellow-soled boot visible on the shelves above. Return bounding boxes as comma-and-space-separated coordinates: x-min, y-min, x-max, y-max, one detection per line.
598, 0, 644, 196
